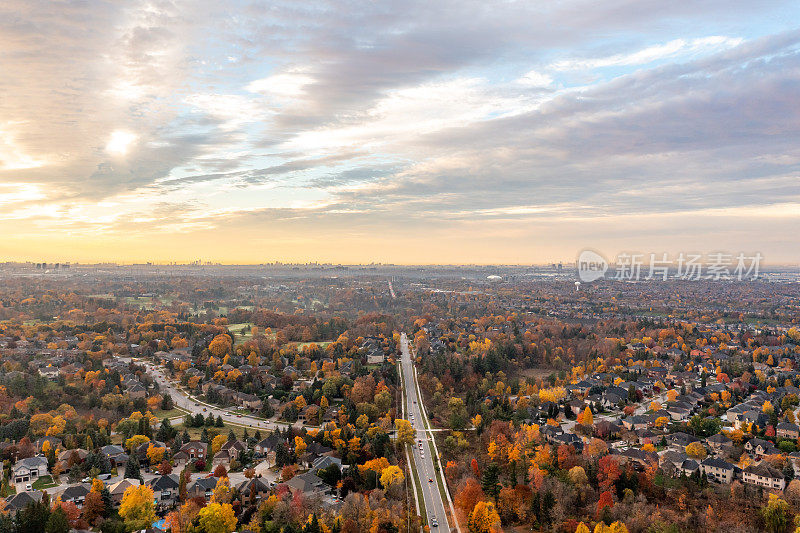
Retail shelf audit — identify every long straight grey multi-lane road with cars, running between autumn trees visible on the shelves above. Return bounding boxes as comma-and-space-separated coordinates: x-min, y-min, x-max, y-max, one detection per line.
400, 333, 450, 531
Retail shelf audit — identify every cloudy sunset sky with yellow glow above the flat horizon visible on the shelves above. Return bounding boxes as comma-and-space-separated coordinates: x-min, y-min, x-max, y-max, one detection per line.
0, 0, 800, 264
